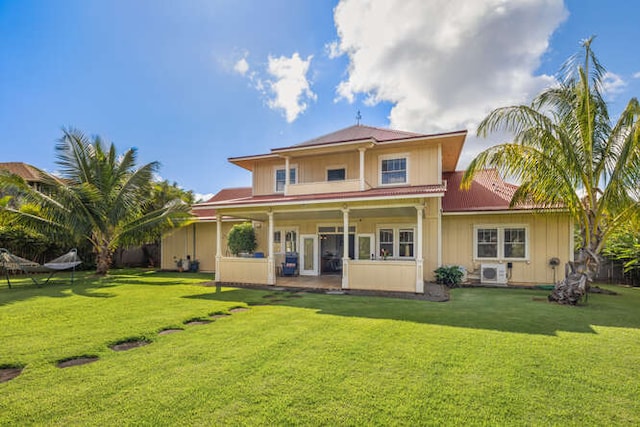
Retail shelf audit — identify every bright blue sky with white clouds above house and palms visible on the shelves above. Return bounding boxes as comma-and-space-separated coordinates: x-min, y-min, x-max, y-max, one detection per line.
0, 0, 640, 201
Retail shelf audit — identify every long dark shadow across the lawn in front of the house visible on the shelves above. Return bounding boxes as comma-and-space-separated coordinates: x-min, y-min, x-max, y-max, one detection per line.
184, 288, 640, 336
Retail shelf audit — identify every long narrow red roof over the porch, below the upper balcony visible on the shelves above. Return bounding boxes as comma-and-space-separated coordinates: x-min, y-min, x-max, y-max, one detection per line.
193, 185, 445, 212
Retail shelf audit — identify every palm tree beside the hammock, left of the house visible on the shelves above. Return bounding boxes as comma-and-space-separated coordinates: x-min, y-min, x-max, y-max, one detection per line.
0, 129, 191, 274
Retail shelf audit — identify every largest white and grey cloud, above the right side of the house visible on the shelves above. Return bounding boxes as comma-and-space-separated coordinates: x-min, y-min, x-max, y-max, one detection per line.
329, 0, 567, 164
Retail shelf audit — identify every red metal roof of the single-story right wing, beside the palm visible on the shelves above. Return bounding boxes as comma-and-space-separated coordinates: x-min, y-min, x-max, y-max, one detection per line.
442, 169, 531, 212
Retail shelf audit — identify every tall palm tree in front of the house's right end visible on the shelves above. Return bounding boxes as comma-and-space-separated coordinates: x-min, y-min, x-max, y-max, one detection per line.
462, 37, 640, 300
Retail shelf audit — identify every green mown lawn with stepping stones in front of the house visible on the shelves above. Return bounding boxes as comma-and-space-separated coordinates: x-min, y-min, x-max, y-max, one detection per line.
0, 271, 640, 426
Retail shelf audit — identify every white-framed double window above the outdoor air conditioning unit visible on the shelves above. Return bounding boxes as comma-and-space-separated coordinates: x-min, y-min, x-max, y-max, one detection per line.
475, 226, 528, 260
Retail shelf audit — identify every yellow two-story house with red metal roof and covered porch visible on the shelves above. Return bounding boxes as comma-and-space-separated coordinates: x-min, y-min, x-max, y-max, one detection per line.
163, 125, 573, 293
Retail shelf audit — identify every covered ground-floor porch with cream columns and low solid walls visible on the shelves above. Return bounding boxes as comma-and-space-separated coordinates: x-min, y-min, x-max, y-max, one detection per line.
209, 197, 441, 294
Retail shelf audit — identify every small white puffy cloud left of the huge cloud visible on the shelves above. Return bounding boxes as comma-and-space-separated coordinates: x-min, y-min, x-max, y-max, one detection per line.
260, 52, 316, 123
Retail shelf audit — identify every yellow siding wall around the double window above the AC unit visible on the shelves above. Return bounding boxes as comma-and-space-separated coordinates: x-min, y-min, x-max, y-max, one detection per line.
442, 213, 573, 284
